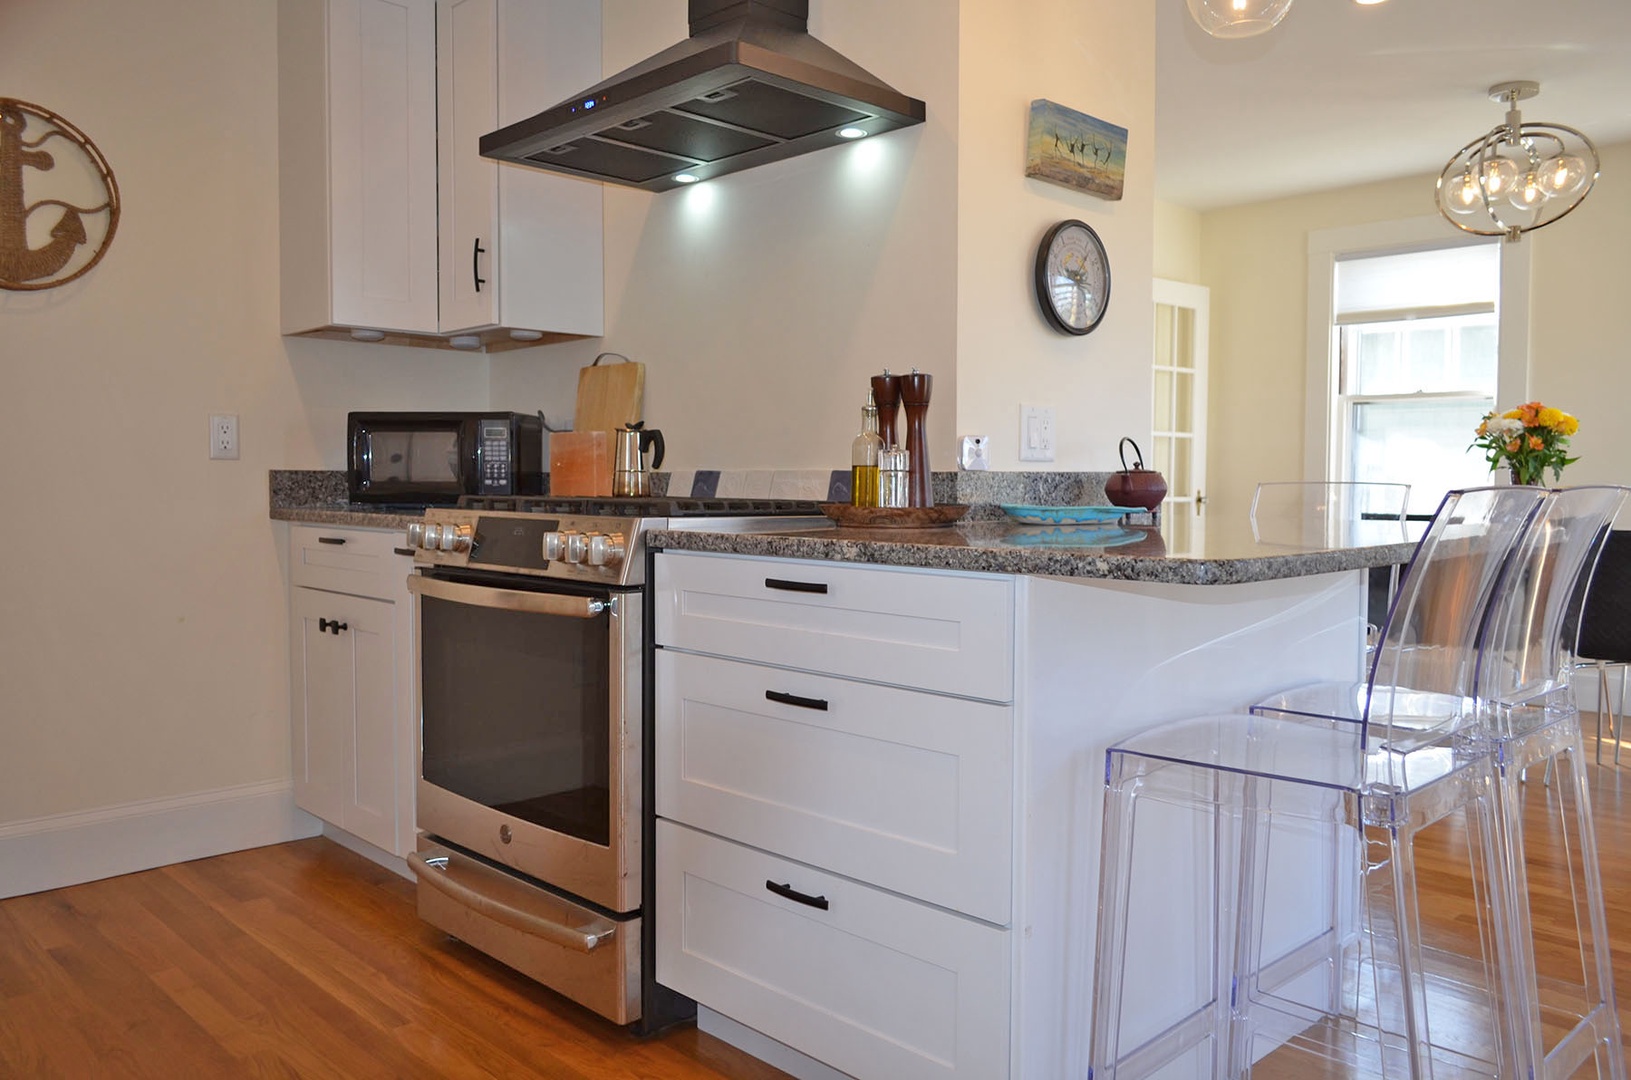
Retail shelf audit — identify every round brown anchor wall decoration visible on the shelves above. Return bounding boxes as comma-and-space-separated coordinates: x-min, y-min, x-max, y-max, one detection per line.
0, 98, 119, 290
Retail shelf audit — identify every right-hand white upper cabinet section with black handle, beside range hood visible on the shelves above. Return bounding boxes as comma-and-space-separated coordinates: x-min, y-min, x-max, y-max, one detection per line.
437, 0, 605, 339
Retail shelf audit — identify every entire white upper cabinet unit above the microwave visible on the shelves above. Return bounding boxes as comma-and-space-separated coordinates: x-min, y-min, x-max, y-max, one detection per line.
277, 0, 603, 349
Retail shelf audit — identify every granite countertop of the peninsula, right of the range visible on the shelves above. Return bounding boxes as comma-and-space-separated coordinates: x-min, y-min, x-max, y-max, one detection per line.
646, 520, 1416, 586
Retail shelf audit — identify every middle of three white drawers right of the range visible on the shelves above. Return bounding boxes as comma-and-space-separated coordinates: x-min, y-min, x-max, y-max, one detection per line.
656, 649, 1013, 923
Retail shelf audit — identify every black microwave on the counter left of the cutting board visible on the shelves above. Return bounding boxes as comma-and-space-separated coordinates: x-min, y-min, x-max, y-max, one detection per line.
346, 413, 543, 506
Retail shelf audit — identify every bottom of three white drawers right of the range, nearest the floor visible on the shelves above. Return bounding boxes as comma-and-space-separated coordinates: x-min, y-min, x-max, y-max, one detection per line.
657, 819, 1010, 1080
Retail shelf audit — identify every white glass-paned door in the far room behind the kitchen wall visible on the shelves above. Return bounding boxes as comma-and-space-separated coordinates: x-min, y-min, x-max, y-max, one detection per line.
1147, 277, 1210, 555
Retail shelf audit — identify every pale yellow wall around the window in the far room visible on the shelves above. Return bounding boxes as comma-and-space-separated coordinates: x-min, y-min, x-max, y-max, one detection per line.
1200, 144, 1631, 531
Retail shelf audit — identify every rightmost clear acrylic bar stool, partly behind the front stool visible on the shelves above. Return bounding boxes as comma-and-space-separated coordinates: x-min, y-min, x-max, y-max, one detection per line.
1476, 486, 1628, 1080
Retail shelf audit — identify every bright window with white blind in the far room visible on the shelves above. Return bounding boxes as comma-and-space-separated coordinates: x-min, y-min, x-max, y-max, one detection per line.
1331, 241, 1501, 514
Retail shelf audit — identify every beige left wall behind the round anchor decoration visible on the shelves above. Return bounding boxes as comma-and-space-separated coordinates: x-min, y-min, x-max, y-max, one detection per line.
0, 0, 488, 824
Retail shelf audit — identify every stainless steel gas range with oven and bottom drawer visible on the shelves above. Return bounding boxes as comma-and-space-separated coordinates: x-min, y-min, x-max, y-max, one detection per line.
408, 496, 825, 1023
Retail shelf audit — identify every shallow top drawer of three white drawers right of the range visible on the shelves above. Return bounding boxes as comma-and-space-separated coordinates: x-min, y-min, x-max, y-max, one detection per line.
656, 551, 1014, 702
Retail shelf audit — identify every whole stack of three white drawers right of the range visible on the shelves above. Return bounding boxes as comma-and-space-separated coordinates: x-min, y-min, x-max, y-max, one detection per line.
654, 551, 1014, 1080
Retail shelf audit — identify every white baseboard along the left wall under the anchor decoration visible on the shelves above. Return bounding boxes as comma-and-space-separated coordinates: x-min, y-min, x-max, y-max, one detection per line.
0, 780, 323, 899
